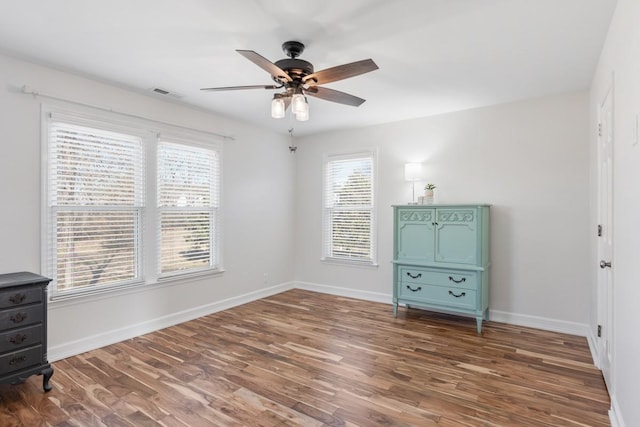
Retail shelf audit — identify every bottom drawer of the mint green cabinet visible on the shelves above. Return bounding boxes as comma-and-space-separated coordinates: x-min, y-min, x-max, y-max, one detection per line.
400, 282, 476, 310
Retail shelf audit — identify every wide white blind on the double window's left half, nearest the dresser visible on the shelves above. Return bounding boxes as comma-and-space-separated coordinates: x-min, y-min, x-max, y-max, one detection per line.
47, 120, 145, 294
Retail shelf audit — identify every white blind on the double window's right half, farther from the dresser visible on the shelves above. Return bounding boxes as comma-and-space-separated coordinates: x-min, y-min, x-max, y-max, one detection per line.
157, 141, 220, 275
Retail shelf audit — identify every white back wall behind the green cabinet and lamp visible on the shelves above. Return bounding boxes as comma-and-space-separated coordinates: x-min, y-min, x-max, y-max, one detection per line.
295, 92, 590, 335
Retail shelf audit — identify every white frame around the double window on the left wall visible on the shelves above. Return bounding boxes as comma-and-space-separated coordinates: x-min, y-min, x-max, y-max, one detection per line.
41, 103, 224, 300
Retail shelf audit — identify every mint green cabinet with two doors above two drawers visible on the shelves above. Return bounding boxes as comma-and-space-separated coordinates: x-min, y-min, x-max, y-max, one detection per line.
393, 205, 490, 332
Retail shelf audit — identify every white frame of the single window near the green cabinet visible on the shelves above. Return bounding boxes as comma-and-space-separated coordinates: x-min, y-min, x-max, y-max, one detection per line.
321, 149, 378, 267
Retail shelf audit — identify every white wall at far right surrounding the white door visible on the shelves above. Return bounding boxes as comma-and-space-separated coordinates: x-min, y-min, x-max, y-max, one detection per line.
590, 0, 640, 427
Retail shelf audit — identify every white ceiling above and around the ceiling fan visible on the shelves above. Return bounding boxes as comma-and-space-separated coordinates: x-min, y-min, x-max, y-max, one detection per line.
0, 0, 616, 136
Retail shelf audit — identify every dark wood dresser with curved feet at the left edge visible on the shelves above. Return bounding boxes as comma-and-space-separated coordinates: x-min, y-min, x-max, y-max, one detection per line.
0, 272, 53, 391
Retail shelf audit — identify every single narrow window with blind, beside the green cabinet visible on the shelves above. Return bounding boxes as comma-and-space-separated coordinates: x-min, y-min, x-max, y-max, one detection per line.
323, 152, 376, 264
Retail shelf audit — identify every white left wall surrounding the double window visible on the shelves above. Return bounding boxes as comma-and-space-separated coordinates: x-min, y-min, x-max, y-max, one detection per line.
0, 56, 295, 360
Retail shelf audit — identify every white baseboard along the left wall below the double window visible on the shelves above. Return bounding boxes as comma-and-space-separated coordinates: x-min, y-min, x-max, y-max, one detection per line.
47, 282, 294, 362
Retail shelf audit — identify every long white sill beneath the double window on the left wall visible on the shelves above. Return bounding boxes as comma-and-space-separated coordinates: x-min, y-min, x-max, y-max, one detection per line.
48, 269, 224, 309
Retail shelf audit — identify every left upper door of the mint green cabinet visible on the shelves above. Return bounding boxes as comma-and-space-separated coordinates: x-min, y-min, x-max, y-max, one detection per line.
396, 209, 435, 263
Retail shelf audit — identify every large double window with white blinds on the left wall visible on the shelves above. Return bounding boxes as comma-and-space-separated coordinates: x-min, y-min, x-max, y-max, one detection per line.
44, 110, 220, 298
